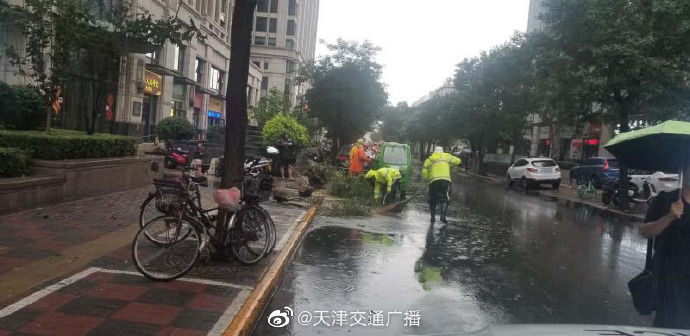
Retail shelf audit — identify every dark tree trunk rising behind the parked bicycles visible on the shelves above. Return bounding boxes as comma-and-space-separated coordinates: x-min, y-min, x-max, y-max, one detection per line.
220, 0, 256, 188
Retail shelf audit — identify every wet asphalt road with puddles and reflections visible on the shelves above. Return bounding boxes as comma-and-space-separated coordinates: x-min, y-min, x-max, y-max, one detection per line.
254, 178, 650, 335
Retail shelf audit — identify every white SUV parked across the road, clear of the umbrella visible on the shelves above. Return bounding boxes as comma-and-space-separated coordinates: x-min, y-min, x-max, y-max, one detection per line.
506, 158, 561, 190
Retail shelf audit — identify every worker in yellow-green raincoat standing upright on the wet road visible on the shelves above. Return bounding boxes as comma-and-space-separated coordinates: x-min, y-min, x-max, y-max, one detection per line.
422, 147, 462, 223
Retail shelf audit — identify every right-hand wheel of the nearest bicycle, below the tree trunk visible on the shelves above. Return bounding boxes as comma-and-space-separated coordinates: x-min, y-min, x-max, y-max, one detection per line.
228, 207, 271, 265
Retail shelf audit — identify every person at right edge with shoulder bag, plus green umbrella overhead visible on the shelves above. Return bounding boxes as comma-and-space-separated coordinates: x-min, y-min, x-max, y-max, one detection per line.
604, 121, 690, 329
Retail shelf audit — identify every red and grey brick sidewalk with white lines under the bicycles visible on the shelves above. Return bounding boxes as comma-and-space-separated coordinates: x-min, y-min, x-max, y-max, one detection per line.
0, 181, 305, 336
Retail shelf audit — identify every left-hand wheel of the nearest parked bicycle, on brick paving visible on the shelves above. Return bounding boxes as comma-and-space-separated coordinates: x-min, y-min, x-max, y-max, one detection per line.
132, 215, 202, 281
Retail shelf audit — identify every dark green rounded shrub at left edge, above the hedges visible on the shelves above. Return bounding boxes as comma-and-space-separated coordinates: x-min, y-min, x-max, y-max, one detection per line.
0, 83, 46, 130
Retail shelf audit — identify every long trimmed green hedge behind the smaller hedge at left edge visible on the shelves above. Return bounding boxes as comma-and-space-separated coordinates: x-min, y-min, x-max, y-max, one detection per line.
0, 130, 138, 160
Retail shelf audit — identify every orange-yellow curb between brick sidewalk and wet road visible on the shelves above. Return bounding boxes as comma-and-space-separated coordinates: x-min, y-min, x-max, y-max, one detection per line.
223, 205, 318, 336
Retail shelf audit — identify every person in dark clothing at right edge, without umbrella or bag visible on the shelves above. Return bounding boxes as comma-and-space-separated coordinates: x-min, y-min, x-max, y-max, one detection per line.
640, 166, 690, 329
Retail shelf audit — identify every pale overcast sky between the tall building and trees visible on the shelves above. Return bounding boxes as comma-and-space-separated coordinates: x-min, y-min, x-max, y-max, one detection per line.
316, 0, 529, 104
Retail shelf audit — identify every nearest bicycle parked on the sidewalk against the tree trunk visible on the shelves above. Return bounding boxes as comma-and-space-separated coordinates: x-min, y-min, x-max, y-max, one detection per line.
132, 168, 276, 281
